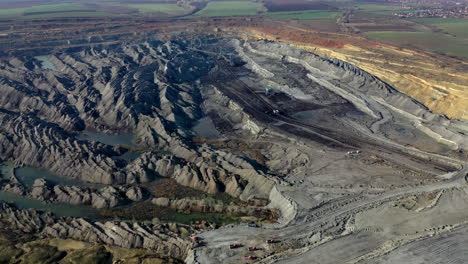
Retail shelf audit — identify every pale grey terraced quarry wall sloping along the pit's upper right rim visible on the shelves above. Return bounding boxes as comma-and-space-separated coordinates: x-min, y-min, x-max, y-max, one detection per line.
239, 41, 468, 150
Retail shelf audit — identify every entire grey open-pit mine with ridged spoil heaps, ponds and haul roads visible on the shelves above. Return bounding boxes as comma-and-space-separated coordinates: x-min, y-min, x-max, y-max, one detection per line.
0, 13, 468, 264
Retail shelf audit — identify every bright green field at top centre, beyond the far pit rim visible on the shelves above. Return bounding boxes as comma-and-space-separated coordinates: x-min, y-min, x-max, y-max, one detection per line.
195, 1, 262, 17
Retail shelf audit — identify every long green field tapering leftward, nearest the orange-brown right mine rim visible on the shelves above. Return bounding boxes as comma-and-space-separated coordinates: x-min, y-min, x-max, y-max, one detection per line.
366, 31, 468, 58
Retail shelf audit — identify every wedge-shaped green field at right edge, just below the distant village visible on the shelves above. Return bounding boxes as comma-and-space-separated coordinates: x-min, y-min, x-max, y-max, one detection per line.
411, 18, 468, 38
